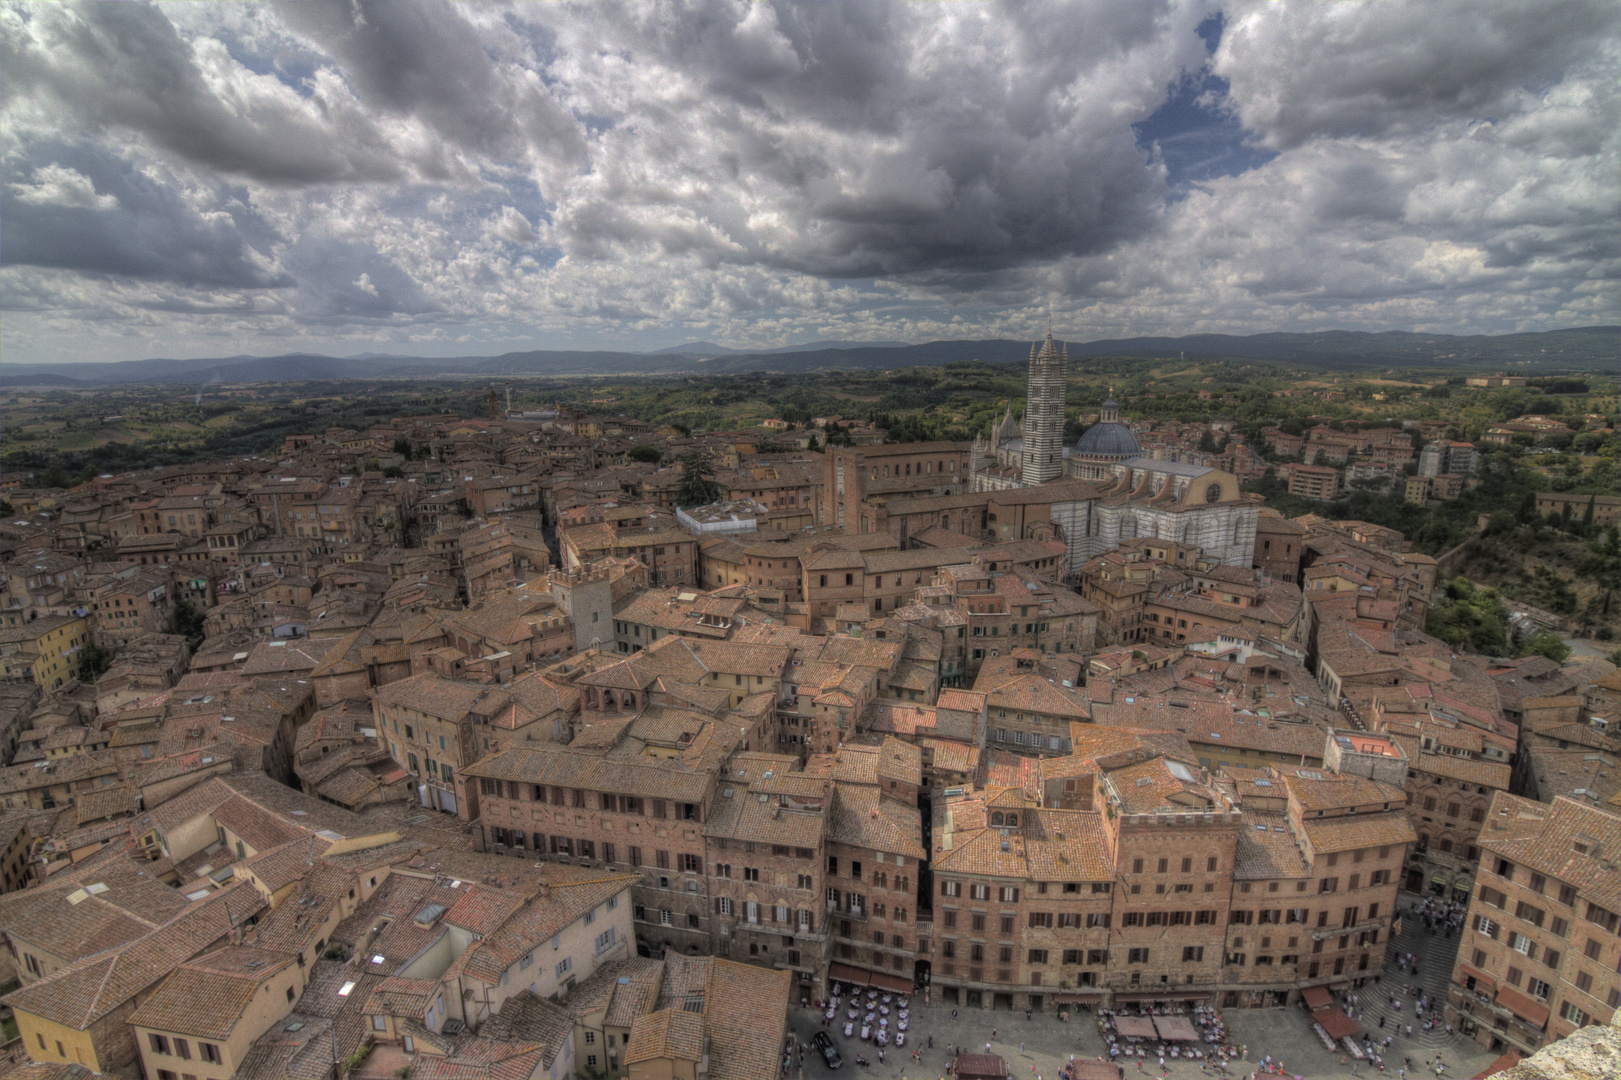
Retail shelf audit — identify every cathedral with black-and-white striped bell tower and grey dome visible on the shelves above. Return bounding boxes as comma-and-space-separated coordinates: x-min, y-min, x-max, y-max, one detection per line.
968, 332, 1260, 569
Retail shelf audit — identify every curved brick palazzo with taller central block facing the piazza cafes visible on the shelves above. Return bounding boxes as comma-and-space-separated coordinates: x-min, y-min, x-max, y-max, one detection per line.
930, 728, 1414, 1009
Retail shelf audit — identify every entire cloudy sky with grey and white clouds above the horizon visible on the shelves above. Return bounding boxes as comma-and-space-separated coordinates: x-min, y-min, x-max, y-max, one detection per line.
0, 0, 1621, 362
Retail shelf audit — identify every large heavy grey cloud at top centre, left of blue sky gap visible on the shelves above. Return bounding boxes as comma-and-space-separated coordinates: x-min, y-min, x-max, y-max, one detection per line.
541, 3, 1204, 277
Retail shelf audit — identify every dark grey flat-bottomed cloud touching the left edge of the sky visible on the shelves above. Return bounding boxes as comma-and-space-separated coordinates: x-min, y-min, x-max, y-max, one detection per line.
0, 144, 293, 289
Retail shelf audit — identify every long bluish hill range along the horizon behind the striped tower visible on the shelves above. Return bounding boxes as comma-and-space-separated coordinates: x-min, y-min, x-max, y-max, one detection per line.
0, 326, 1621, 386
